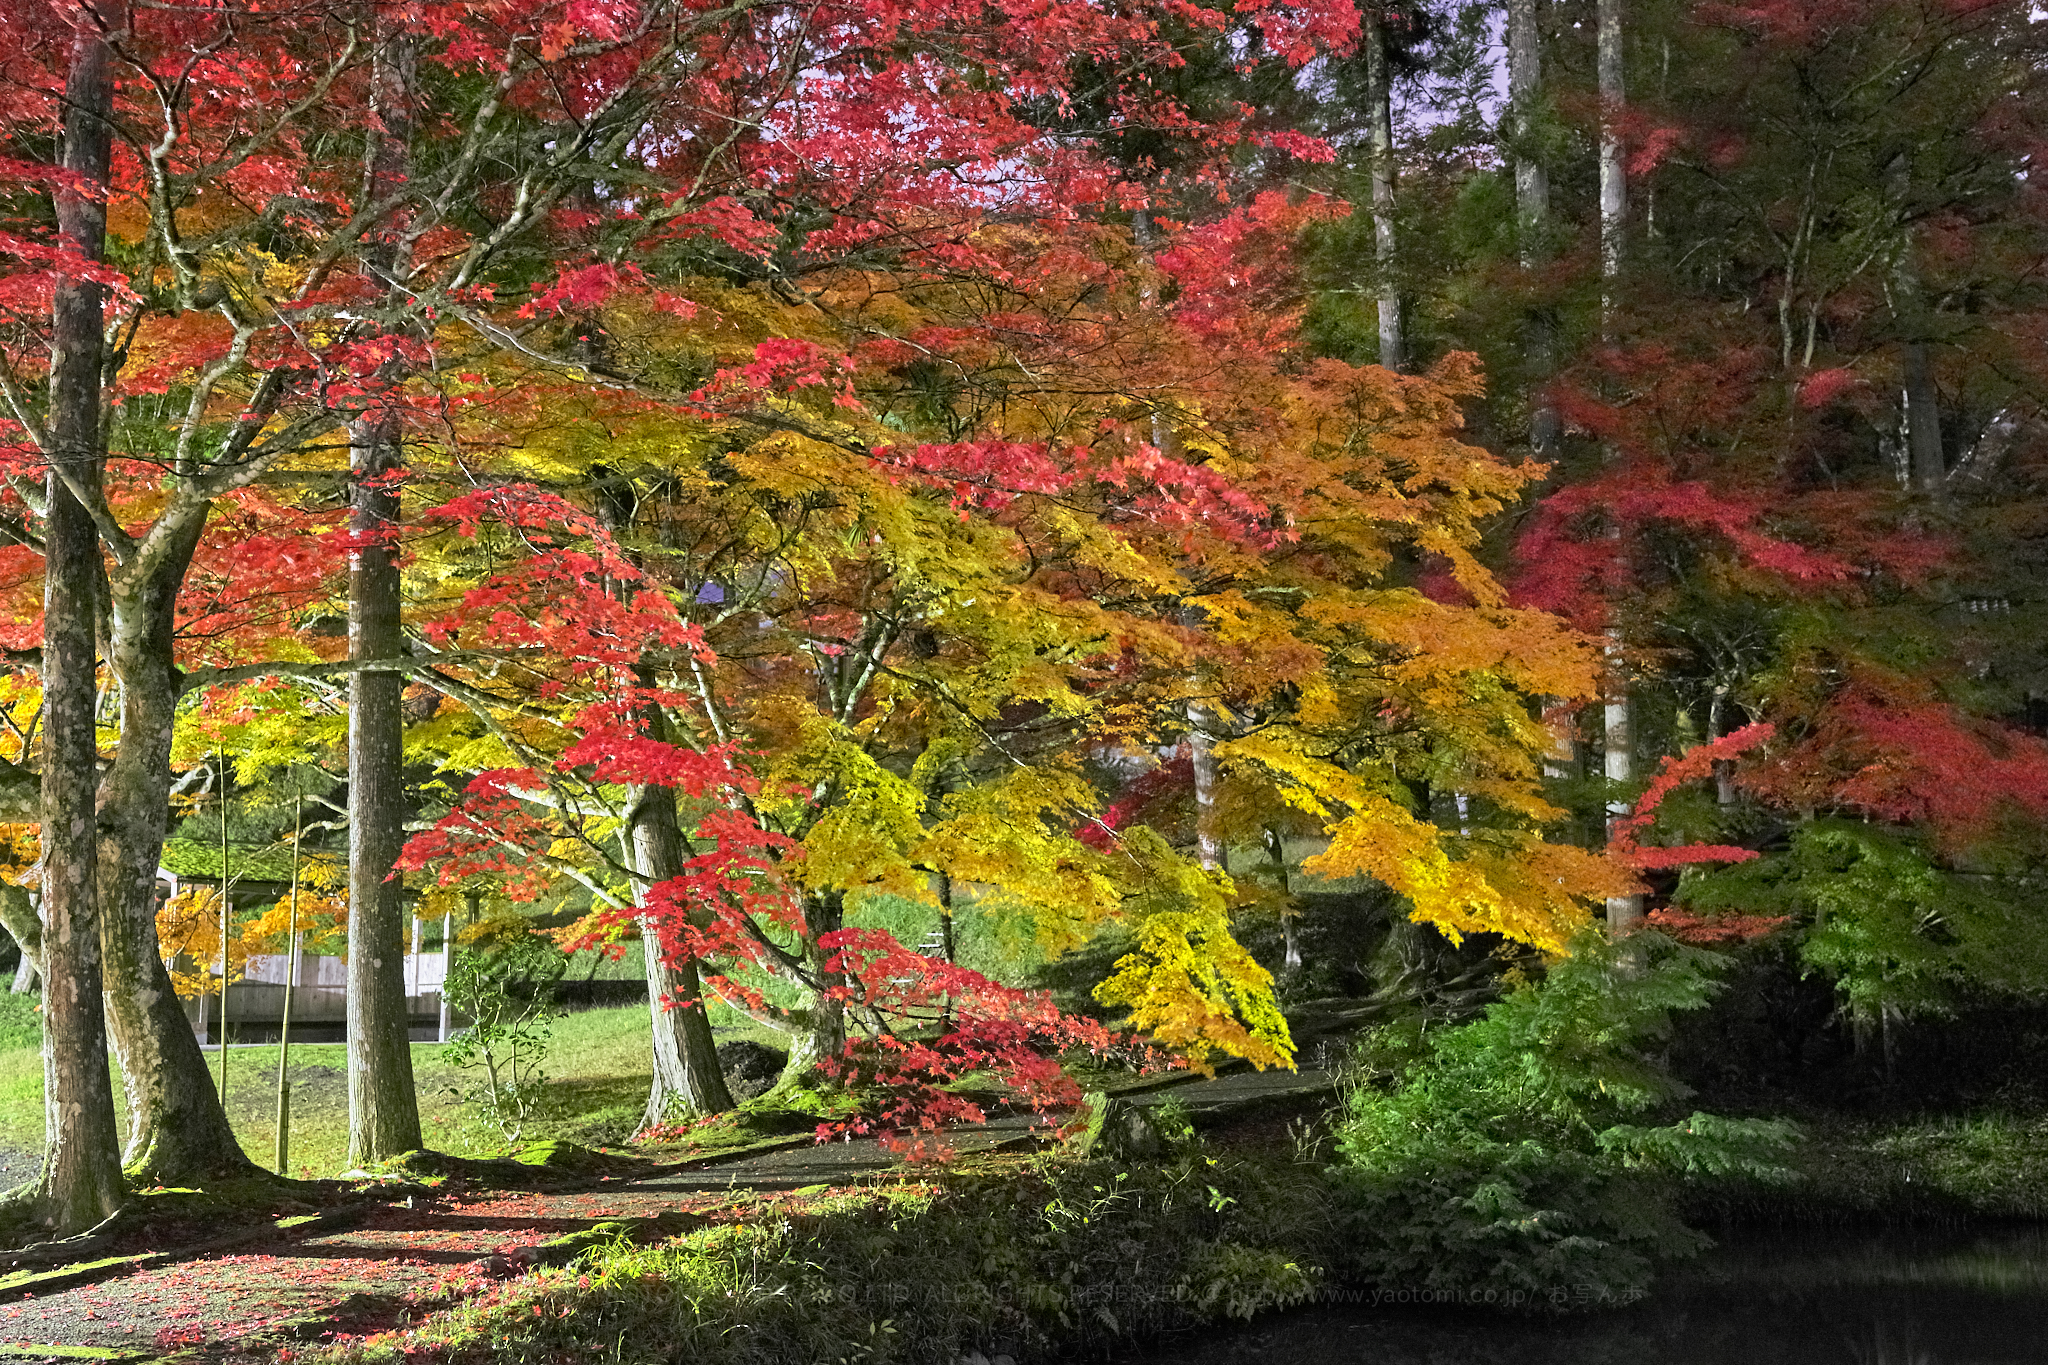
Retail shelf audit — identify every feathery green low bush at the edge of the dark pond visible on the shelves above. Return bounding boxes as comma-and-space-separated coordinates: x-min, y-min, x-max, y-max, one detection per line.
1337, 933, 1794, 1306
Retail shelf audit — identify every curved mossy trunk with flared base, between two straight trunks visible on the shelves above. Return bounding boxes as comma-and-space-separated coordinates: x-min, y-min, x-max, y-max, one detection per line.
98, 518, 256, 1185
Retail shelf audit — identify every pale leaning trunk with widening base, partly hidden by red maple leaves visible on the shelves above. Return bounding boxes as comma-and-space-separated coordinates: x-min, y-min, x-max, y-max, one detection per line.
627, 786, 733, 1130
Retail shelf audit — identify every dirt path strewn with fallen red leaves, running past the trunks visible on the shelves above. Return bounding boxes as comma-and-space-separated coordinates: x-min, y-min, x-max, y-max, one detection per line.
0, 1072, 1327, 1361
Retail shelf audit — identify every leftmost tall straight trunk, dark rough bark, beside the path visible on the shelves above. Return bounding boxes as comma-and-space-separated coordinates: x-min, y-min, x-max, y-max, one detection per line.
37, 20, 123, 1234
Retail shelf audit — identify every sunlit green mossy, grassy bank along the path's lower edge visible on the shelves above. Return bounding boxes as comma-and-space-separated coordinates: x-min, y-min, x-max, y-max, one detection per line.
296, 1152, 1341, 1365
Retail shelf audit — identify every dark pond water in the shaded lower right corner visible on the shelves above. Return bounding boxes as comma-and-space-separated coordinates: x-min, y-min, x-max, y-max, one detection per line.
1126, 1228, 2048, 1365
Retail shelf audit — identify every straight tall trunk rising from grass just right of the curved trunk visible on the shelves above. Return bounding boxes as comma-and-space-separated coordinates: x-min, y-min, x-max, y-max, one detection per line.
348, 35, 420, 1164
